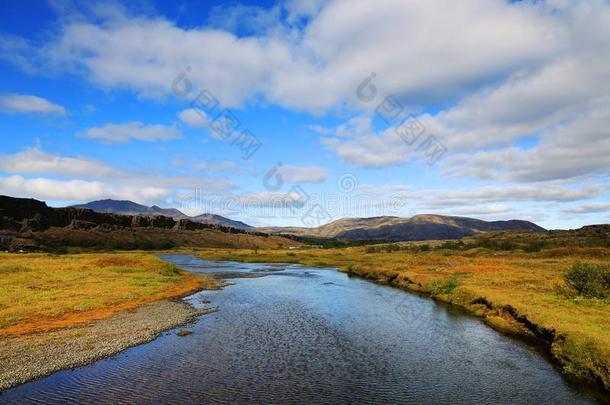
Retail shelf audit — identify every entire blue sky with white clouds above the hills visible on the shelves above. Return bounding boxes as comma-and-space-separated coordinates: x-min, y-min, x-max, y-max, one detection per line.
0, 0, 610, 228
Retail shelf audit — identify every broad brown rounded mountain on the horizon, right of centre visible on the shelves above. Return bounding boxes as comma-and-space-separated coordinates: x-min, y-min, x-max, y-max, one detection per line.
259, 215, 545, 241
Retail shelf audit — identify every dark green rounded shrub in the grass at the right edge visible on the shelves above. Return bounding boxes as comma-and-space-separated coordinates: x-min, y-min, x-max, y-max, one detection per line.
564, 263, 610, 298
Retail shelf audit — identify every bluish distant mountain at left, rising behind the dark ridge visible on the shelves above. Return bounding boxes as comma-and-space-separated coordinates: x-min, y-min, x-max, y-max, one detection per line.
73, 199, 252, 229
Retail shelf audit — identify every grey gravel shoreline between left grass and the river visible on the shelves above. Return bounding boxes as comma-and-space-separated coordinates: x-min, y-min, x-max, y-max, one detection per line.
0, 300, 211, 392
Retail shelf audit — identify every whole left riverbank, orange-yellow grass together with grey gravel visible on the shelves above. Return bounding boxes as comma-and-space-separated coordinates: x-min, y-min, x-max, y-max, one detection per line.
0, 253, 222, 391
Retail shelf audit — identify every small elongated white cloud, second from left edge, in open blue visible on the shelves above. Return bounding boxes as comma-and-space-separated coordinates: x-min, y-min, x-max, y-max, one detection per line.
79, 122, 182, 143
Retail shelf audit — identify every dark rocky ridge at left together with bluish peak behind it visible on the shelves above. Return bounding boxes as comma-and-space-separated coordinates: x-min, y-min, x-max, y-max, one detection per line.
0, 195, 290, 253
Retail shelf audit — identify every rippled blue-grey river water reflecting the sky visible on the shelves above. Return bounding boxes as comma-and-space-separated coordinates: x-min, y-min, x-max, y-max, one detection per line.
0, 255, 593, 404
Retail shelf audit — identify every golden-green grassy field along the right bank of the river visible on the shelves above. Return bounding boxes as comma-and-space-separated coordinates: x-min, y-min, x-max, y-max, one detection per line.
197, 247, 610, 390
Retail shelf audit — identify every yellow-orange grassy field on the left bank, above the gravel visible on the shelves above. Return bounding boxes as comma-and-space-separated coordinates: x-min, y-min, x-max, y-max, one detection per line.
0, 253, 216, 337
